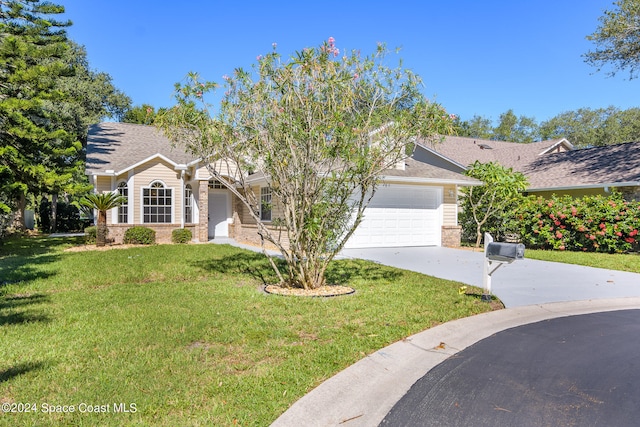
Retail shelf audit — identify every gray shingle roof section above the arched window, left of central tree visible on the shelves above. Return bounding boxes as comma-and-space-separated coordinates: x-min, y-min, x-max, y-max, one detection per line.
86, 122, 196, 175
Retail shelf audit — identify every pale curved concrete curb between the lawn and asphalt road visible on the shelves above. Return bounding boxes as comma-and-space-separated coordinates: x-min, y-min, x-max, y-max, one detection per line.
272, 297, 640, 427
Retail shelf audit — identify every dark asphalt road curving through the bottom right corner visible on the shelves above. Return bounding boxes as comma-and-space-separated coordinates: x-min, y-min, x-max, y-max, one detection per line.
380, 310, 640, 427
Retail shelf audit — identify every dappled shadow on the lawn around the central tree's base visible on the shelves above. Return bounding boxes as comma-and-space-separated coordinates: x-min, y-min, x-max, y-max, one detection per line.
192, 252, 402, 285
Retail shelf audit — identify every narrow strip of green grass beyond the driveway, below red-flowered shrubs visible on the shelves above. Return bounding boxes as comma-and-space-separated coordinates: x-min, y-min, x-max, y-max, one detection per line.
524, 249, 640, 273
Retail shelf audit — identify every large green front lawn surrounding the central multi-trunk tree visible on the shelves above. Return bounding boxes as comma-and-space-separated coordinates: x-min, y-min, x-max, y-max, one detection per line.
0, 238, 491, 426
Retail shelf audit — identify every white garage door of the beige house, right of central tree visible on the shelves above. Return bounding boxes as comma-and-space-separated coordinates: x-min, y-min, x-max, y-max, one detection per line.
345, 185, 442, 248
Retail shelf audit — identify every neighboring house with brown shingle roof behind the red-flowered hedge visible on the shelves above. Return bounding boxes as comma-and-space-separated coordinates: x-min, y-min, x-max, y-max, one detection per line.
421, 136, 640, 199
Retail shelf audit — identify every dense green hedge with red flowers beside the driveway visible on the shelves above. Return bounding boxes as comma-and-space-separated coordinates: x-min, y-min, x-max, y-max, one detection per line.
510, 193, 640, 253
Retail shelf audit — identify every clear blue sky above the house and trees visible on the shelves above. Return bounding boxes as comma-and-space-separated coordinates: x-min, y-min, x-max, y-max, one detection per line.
62, 0, 640, 122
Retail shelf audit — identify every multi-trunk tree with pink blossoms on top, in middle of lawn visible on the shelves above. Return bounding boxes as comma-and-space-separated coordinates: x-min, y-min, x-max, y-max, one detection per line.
156, 38, 453, 289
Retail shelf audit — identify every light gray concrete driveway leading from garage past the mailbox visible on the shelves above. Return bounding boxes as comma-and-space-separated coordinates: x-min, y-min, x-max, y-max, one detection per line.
341, 247, 640, 308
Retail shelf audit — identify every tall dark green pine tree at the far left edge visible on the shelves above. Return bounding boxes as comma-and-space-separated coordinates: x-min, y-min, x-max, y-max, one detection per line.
0, 0, 74, 226
